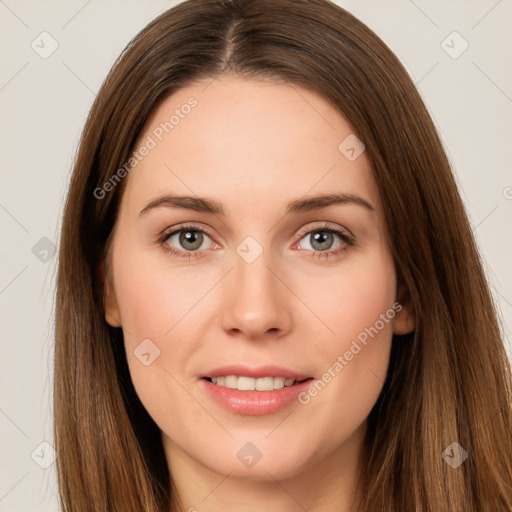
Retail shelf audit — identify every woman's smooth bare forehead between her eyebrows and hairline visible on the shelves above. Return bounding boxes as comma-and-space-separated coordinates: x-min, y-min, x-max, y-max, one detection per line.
120, 75, 379, 218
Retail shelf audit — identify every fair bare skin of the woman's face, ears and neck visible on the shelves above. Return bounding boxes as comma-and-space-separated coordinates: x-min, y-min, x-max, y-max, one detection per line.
105, 74, 414, 512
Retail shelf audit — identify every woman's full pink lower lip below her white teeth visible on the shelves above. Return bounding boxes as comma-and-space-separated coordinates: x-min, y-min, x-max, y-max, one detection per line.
201, 378, 313, 416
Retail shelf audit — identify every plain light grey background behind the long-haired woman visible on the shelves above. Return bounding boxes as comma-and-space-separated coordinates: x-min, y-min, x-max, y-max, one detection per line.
0, 0, 512, 512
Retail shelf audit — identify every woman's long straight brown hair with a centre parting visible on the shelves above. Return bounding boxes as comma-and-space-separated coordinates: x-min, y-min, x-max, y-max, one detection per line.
54, 0, 512, 512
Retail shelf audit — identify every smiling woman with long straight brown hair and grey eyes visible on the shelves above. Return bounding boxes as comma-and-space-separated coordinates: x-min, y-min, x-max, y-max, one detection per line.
55, 0, 512, 512
